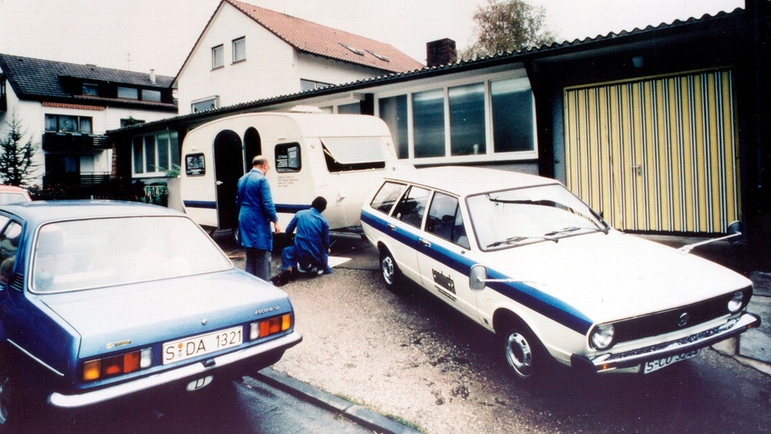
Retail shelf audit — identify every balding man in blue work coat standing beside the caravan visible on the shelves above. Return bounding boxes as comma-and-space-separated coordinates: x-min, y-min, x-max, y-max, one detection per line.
236, 155, 281, 281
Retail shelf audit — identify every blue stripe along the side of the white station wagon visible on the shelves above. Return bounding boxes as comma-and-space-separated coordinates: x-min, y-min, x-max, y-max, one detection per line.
361, 211, 592, 334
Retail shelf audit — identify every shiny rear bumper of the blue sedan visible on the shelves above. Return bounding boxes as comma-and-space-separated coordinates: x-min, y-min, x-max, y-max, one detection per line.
48, 332, 302, 408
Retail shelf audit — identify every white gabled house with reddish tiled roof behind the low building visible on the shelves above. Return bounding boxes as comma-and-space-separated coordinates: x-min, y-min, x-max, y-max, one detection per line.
173, 0, 423, 114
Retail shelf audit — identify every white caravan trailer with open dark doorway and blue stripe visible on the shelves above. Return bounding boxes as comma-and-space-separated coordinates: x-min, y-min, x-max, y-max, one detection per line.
180, 113, 414, 230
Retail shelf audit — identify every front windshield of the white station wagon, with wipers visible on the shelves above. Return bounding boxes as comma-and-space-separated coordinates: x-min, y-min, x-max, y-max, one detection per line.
466, 184, 609, 250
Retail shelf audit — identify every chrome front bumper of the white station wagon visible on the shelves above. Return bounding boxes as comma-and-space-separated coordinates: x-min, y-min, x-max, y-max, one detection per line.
571, 313, 760, 373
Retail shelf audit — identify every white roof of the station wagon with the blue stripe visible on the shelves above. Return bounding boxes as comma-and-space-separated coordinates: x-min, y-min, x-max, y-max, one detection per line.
386, 166, 560, 196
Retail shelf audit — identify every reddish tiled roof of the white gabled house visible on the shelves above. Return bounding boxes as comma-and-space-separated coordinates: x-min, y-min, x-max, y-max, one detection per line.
225, 0, 424, 72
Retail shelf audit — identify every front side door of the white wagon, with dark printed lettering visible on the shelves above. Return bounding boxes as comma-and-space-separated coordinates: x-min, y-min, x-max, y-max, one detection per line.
417, 191, 479, 320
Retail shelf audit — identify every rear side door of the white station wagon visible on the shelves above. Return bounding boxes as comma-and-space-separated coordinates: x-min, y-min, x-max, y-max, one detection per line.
387, 185, 431, 288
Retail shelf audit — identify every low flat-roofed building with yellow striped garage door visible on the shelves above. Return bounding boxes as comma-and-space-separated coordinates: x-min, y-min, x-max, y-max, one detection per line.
109, 0, 771, 264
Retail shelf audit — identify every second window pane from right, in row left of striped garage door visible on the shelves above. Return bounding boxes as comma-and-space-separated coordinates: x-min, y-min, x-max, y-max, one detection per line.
448, 83, 486, 155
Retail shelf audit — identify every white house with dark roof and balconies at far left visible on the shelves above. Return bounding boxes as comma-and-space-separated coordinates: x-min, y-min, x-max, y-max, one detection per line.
0, 54, 179, 187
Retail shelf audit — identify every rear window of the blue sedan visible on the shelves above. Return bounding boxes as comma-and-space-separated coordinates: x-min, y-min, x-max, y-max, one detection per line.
32, 217, 232, 292
